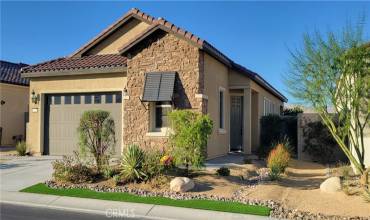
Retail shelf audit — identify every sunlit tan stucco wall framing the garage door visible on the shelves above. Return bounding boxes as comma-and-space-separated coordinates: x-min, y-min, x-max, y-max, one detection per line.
27, 72, 127, 154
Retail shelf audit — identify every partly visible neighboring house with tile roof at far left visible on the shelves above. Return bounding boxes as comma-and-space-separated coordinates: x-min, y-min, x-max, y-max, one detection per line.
0, 61, 29, 146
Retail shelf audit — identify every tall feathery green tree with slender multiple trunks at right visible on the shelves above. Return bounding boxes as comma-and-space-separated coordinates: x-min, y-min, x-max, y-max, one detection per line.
286, 21, 370, 178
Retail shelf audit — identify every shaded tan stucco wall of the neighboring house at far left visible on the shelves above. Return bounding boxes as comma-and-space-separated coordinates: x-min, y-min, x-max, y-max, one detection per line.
0, 83, 29, 146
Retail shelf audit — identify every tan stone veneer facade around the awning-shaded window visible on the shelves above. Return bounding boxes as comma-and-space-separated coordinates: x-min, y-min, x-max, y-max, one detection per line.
123, 31, 206, 149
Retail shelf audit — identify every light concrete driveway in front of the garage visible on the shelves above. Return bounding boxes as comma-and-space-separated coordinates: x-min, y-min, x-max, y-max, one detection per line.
0, 156, 60, 192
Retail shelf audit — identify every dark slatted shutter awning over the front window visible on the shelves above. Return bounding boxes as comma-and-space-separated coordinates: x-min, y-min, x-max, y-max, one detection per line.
142, 72, 176, 102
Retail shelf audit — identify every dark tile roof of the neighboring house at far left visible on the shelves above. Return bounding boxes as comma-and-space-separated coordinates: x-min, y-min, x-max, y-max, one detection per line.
0, 60, 29, 86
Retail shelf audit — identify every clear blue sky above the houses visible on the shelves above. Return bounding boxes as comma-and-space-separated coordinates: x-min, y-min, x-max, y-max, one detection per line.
0, 1, 370, 102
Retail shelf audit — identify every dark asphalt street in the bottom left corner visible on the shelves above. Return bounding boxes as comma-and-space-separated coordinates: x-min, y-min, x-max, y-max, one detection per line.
0, 203, 150, 220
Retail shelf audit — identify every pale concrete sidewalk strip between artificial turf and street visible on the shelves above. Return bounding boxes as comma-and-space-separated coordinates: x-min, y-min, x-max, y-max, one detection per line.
1, 191, 269, 220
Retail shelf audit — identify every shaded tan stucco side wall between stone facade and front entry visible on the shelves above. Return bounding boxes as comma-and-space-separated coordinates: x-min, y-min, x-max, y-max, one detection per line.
204, 54, 230, 158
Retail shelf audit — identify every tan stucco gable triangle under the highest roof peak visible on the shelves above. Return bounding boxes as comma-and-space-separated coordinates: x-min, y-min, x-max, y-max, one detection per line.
86, 19, 149, 55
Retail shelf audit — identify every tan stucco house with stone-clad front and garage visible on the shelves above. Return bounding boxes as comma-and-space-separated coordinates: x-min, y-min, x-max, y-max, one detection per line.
22, 9, 287, 158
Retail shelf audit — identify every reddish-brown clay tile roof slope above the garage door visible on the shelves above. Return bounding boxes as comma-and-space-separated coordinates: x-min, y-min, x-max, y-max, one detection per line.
21, 54, 127, 73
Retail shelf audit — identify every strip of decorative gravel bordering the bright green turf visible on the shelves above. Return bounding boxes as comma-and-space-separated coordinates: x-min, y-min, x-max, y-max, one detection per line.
45, 181, 370, 220
